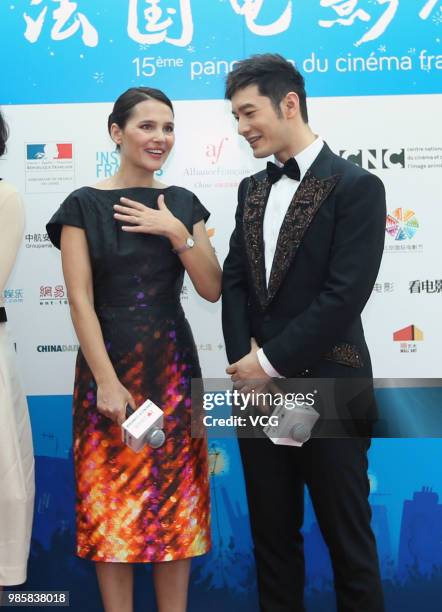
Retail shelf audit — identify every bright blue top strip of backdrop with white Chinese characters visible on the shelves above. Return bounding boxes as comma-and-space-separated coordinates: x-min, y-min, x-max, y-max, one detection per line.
0, 0, 442, 104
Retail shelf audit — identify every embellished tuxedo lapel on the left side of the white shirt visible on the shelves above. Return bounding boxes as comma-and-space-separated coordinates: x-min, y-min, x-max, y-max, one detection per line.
243, 176, 271, 309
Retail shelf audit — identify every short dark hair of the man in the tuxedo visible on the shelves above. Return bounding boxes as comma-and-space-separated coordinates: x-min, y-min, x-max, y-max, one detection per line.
225, 53, 308, 123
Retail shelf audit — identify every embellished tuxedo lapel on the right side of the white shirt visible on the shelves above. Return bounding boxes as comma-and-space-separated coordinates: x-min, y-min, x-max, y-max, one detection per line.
261, 170, 340, 305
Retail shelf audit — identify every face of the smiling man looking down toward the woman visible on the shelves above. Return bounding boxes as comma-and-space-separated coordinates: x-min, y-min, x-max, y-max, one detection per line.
232, 85, 293, 162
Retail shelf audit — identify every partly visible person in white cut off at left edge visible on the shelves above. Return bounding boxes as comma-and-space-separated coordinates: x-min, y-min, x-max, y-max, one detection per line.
0, 113, 34, 591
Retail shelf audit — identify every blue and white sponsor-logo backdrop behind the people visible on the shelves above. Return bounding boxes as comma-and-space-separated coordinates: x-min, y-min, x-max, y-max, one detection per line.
0, 0, 442, 612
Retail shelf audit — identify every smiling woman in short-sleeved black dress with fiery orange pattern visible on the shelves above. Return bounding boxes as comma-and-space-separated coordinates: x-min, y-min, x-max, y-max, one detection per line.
47, 87, 221, 612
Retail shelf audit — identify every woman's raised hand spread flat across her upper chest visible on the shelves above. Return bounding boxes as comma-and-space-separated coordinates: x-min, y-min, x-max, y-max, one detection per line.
114, 194, 181, 237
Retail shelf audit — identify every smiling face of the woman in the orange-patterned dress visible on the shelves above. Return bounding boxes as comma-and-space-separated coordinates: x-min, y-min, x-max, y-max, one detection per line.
111, 100, 175, 172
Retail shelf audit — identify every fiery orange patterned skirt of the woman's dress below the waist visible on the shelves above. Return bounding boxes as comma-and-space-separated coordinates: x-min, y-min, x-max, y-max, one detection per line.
74, 307, 210, 563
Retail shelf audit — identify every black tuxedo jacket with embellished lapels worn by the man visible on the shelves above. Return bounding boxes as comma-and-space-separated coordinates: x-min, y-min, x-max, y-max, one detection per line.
223, 144, 386, 378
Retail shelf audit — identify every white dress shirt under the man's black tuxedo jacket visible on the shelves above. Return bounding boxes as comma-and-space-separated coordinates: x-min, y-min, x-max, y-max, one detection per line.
257, 138, 324, 378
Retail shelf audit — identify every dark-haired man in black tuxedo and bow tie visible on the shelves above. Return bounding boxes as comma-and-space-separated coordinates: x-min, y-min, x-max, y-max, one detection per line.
223, 54, 386, 612
